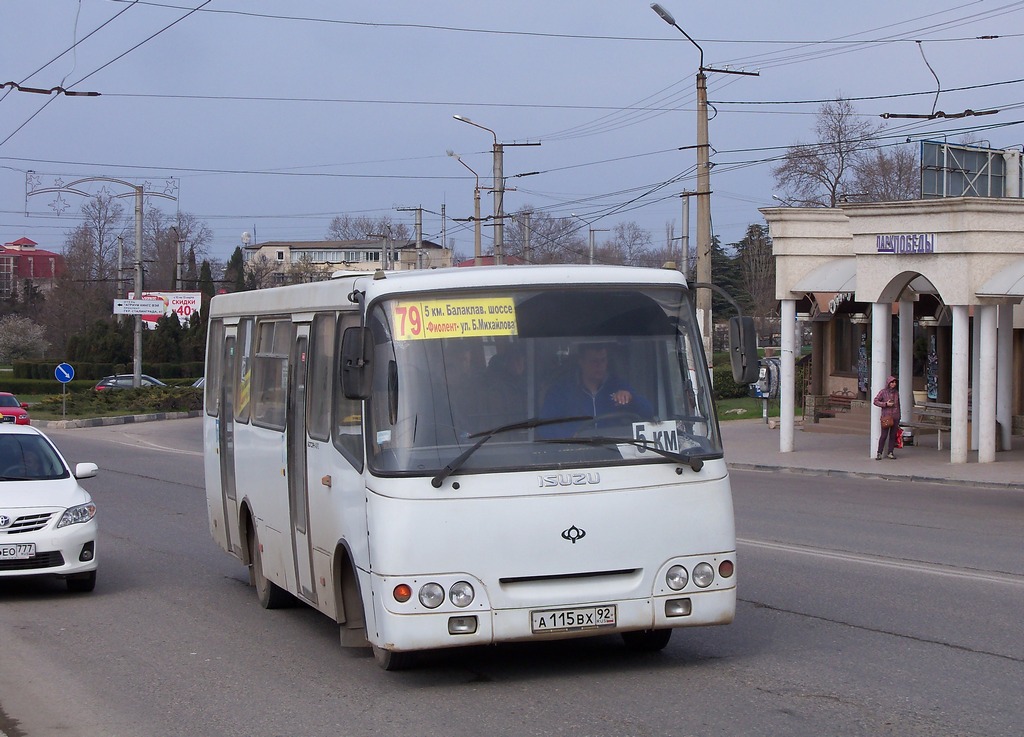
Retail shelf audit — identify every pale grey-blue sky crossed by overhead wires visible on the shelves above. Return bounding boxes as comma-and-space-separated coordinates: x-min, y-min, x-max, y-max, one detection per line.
0, 0, 1024, 259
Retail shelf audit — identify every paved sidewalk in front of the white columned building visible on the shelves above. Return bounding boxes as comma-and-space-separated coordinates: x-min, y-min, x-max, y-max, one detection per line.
721, 418, 1024, 489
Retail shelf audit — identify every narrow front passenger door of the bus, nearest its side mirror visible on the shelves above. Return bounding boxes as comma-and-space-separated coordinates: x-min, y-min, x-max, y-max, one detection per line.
287, 324, 316, 604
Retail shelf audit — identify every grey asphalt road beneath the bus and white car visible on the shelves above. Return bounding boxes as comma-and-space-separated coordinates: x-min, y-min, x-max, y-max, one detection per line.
0, 420, 1024, 737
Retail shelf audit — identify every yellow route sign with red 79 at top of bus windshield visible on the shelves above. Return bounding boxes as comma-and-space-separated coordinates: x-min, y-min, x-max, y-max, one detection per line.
391, 297, 518, 341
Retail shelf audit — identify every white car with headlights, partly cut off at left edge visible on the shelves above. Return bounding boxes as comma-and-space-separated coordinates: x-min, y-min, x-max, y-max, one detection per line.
0, 423, 97, 592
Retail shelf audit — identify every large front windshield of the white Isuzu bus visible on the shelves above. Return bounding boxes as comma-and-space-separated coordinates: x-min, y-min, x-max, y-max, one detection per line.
366, 286, 722, 476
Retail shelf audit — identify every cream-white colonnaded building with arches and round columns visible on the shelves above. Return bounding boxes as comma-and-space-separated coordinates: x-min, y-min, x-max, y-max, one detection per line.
761, 197, 1024, 463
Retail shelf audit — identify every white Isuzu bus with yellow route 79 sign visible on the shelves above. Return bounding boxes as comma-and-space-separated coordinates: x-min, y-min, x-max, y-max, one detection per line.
204, 266, 757, 669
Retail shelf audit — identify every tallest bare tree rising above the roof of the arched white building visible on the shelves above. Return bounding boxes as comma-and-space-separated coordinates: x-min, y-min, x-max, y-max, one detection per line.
772, 97, 884, 208
